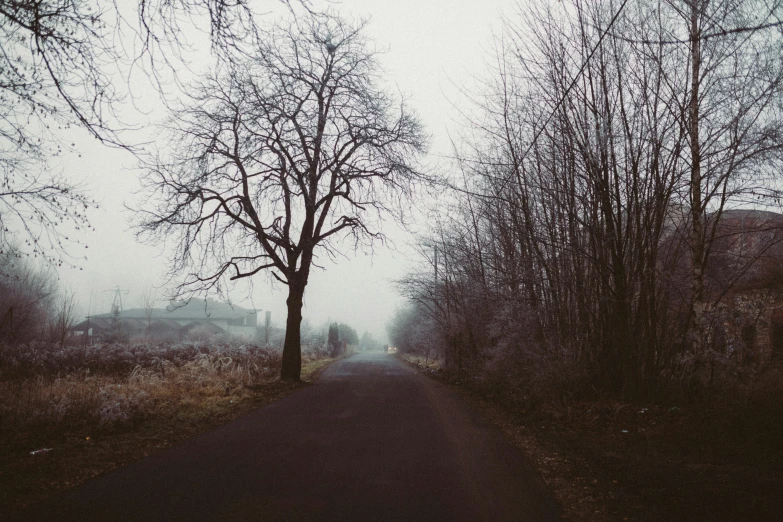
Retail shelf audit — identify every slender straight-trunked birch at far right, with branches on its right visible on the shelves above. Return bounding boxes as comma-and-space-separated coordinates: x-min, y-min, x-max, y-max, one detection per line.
662, 0, 783, 353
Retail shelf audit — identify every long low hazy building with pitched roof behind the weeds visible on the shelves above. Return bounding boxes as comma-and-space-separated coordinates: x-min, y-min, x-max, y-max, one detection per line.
72, 299, 258, 342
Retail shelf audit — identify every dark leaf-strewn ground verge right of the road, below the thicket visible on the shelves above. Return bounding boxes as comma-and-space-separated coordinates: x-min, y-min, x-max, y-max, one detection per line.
402, 355, 783, 522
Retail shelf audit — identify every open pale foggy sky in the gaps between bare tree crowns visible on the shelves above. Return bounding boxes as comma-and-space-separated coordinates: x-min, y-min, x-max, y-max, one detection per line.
47, 0, 514, 343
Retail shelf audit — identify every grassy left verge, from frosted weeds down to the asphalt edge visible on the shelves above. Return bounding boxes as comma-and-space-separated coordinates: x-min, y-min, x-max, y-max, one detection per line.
0, 342, 334, 513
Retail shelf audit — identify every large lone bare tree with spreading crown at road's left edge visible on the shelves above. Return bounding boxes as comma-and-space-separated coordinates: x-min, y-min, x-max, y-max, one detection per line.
140, 14, 425, 380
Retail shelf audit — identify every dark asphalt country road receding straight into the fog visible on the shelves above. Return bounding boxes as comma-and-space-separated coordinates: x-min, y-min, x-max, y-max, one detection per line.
13, 354, 558, 522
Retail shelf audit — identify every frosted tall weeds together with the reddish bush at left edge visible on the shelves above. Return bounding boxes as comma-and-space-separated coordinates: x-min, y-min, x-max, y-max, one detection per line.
0, 251, 346, 442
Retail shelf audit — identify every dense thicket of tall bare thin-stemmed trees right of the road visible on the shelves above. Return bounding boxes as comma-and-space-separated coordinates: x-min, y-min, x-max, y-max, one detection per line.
395, 0, 783, 396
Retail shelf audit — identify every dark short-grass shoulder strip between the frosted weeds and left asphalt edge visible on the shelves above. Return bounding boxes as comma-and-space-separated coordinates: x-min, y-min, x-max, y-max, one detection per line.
0, 359, 335, 513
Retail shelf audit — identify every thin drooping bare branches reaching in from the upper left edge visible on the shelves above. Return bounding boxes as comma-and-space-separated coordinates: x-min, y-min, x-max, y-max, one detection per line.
0, 0, 112, 263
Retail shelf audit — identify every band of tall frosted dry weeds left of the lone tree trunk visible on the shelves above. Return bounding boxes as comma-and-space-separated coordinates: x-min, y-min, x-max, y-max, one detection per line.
0, 342, 290, 434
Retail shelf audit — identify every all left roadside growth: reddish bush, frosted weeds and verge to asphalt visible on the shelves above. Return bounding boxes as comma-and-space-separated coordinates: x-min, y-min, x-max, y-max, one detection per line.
0, 253, 355, 511
